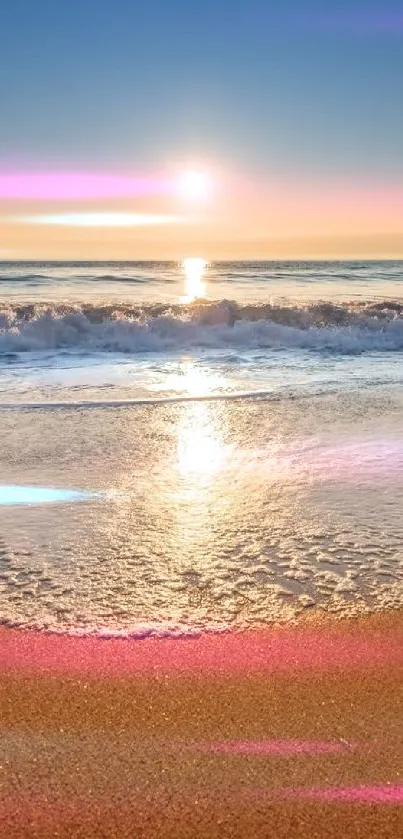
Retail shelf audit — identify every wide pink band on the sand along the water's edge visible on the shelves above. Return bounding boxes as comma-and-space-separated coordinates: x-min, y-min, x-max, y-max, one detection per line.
0, 622, 403, 677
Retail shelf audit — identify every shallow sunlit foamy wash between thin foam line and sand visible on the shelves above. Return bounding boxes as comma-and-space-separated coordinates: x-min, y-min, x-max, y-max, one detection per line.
0, 392, 403, 638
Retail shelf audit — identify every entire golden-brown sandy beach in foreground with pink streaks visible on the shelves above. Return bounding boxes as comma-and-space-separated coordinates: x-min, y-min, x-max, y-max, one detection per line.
0, 613, 403, 839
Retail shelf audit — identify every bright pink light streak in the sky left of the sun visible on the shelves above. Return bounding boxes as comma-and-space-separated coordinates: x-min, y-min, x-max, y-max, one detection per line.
0, 172, 172, 201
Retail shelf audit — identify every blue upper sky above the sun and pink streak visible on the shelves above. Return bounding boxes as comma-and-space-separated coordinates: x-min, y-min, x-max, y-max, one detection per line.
0, 0, 403, 178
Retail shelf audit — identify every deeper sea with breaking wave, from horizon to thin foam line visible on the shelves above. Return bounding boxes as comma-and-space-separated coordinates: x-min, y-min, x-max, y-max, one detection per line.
0, 262, 403, 404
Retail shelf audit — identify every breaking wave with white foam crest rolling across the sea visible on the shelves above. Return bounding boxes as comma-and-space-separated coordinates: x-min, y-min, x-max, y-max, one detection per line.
0, 300, 403, 354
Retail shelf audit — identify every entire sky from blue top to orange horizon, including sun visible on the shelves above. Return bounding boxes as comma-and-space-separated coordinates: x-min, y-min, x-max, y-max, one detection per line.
0, 0, 403, 260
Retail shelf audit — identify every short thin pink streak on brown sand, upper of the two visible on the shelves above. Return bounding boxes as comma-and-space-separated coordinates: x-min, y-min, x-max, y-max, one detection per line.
196, 740, 355, 757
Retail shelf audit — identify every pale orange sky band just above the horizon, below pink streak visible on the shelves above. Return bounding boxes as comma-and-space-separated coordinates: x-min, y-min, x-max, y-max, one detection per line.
0, 169, 403, 260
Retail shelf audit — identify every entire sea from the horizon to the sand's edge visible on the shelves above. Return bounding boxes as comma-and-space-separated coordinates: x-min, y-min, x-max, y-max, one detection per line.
0, 260, 403, 637
